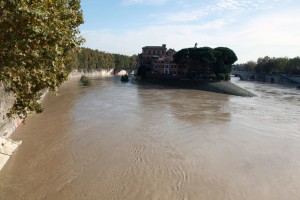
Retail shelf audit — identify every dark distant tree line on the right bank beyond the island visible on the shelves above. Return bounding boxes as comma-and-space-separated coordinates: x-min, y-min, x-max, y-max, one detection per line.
234, 56, 300, 74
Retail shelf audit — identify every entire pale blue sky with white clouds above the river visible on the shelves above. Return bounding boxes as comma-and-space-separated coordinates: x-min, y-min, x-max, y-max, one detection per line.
80, 0, 300, 63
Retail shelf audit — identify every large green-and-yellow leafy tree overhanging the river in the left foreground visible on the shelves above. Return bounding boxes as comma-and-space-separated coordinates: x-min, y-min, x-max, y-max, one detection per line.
0, 0, 83, 118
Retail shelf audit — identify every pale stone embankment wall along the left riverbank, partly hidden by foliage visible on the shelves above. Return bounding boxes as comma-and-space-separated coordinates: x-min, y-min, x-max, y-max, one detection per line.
0, 69, 113, 170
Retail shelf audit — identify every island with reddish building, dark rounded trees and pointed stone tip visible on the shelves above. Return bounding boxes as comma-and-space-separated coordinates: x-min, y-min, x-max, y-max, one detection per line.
137, 43, 254, 96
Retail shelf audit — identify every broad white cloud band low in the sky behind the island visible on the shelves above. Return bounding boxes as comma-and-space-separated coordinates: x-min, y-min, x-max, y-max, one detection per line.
83, 4, 300, 63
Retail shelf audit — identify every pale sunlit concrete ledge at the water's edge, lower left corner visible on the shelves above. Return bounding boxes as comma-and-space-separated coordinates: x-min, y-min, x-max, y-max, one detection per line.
0, 136, 22, 171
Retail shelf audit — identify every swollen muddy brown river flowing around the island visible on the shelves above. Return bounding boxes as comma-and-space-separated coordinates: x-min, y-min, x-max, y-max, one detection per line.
0, 78, 300, 200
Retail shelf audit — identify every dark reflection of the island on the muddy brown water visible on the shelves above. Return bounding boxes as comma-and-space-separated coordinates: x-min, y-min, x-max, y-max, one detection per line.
138, 85, 230, 125
